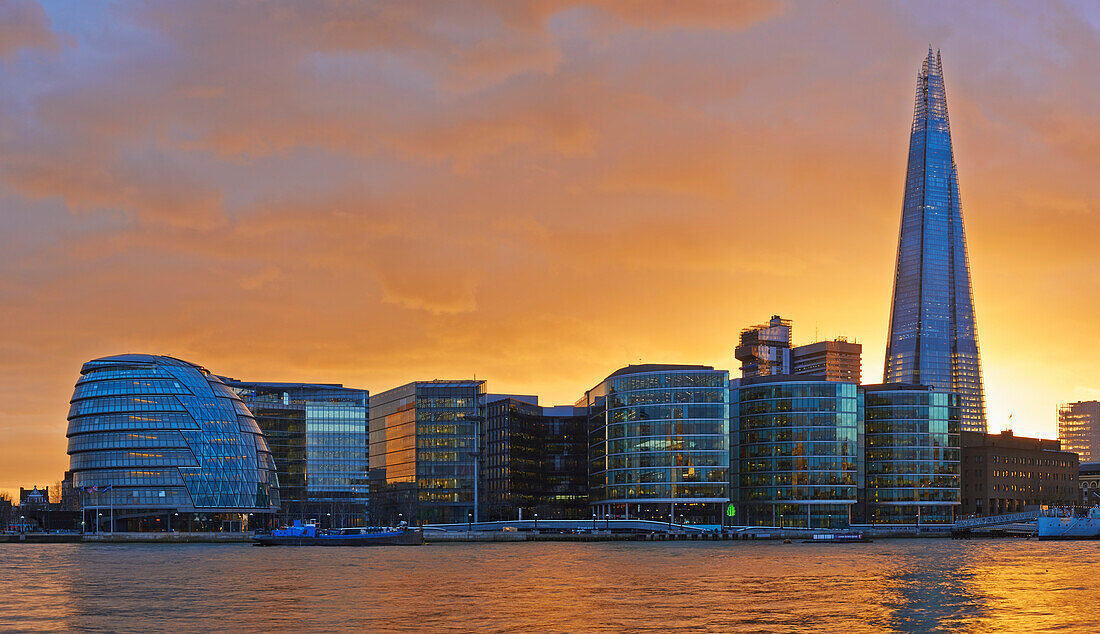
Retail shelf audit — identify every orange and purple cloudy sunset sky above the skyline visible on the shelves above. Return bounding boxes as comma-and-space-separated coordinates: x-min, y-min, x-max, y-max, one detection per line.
0, 0, 1100, 490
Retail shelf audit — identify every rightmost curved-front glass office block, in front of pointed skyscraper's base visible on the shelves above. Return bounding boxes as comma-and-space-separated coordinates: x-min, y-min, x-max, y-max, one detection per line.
861, 384, 961, 524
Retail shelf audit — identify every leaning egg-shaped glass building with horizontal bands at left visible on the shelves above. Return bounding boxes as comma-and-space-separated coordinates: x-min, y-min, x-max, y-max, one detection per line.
66, 354, 278, 531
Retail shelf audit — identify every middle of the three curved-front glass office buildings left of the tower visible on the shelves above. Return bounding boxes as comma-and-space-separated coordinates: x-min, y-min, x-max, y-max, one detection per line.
730, 375, 862, 528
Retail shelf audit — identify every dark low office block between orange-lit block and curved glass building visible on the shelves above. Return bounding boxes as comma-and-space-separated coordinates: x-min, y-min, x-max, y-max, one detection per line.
481, 396, 589, 520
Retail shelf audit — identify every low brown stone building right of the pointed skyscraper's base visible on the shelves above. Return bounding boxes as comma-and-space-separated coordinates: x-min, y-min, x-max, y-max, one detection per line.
960, 431, 1079, 516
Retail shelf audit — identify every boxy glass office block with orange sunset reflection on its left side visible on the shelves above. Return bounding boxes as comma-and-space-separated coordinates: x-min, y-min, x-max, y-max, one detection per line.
369, 381, 485, 524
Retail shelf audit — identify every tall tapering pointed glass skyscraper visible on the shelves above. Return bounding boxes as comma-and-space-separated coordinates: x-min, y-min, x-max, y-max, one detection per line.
883, 48, 986, 431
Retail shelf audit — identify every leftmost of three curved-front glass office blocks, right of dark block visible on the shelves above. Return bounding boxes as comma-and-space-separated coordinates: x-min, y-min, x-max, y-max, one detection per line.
578, 365, 729, 524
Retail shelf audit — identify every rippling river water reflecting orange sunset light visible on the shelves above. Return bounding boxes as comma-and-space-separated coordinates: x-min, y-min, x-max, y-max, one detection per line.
0, 539, 1100, 632
